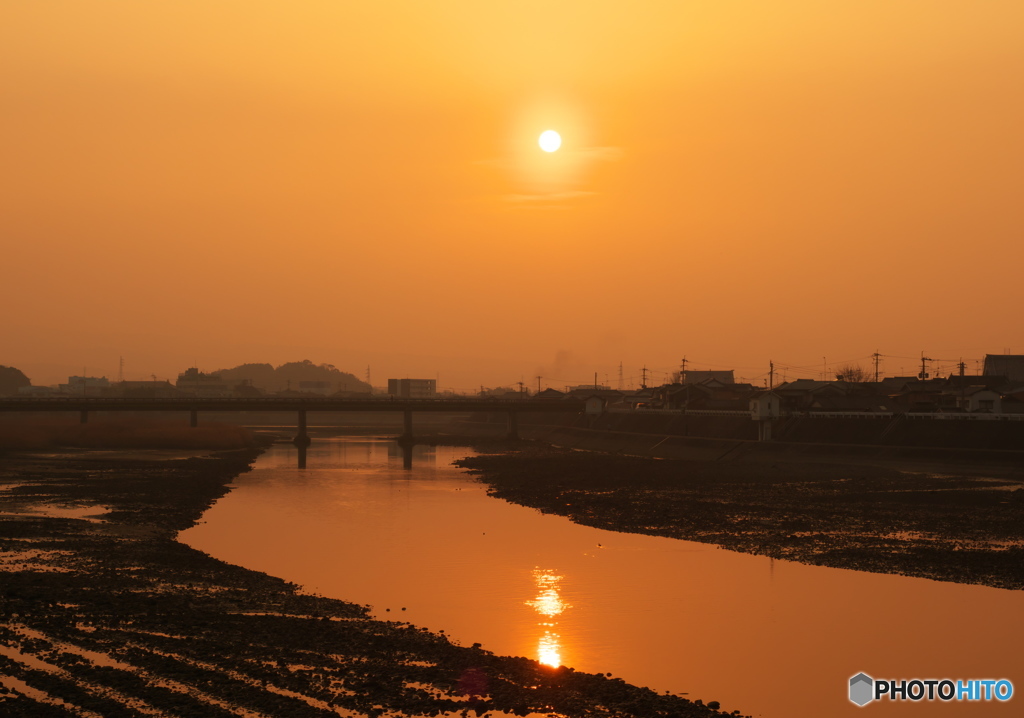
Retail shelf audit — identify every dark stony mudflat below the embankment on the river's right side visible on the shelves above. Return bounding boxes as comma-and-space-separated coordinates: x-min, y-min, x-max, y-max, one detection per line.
460, 445, 1024, 589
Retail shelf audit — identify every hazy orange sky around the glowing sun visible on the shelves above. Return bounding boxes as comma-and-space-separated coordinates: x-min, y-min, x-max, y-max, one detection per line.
0, 0, 1024, 388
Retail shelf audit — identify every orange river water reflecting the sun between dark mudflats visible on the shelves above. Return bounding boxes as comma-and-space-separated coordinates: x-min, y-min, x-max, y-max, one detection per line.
179, 437, 1024, 718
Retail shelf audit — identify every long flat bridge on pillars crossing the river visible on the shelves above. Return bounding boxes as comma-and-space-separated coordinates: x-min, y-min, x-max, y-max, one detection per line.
0, 396, 584, 447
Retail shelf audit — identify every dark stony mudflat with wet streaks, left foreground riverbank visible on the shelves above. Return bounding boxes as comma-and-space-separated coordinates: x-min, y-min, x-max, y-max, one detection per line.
0, 444, 727, 718
